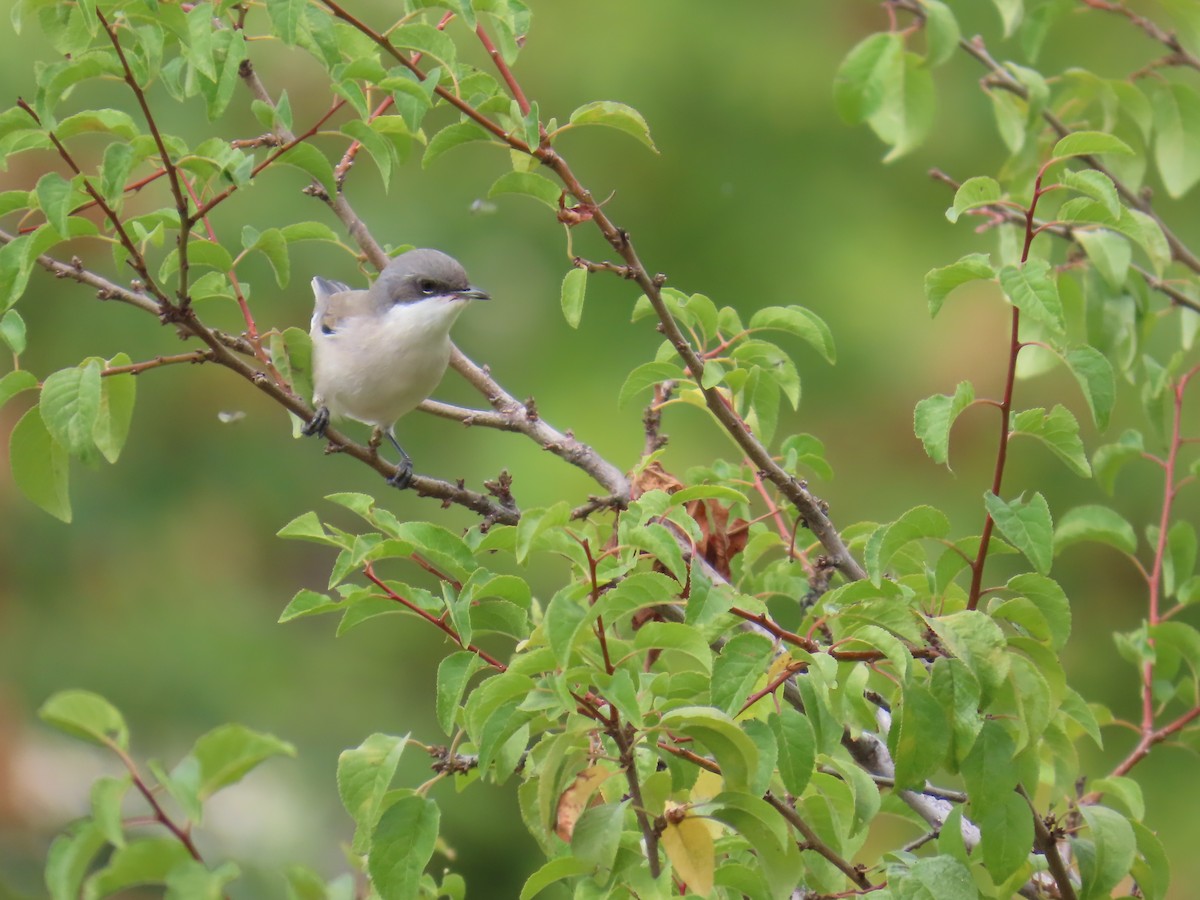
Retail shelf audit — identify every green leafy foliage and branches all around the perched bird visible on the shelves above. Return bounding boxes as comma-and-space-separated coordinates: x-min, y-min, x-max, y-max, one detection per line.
0, 0, 1200, 900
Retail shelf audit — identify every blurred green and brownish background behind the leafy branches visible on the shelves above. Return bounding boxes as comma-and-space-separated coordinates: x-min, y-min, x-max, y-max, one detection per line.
0, 0, 1200, 898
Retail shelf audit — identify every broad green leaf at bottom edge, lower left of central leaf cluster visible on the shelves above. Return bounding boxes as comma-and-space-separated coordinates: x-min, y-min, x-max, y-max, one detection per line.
367, 794, 440, 900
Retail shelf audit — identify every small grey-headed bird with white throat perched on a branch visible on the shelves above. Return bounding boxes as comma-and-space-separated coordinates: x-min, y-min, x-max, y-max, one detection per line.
302, 250, 488, 488
